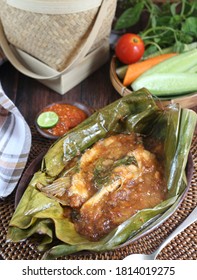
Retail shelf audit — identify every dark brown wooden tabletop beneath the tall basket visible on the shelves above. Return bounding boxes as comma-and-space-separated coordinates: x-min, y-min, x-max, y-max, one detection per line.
0, 55, 197, 262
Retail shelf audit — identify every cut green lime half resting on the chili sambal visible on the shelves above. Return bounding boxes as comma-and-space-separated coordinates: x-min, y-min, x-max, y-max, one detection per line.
37, 111, 59, 128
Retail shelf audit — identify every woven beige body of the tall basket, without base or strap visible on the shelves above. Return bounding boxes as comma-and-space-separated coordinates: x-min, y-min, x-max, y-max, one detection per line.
0, 0, 116, 71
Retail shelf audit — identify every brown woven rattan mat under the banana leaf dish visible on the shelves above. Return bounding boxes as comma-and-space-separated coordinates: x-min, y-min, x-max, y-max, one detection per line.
0, 127, 197, 260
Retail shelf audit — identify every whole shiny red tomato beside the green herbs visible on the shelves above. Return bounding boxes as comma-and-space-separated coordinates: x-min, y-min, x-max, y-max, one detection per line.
115, 33, 145, 64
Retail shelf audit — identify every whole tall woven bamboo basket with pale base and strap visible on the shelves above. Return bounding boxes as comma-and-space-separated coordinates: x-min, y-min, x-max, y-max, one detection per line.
0, 0, 117, 94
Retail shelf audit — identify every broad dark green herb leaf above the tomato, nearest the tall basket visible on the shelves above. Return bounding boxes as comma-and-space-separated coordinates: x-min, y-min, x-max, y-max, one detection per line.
115, 2, 144, 30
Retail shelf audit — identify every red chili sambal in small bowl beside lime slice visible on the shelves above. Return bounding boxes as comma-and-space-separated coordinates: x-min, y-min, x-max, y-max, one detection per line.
43, 103, 88, 136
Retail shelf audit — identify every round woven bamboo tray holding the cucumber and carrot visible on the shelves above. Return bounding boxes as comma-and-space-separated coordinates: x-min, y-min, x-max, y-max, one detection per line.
110, 56, 197, 108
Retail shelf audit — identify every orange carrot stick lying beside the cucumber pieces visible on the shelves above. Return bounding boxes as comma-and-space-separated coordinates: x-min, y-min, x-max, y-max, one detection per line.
123, 53, 177, 87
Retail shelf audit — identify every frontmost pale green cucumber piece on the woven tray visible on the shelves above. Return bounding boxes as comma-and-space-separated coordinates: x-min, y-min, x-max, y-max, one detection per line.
132, 73, 197, 96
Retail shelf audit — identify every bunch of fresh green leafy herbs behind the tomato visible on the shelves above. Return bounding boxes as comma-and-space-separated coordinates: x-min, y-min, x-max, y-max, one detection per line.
115, 0, 197, 54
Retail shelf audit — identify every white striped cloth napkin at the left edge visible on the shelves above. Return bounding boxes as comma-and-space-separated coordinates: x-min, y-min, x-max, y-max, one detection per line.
0, 84, 31, 198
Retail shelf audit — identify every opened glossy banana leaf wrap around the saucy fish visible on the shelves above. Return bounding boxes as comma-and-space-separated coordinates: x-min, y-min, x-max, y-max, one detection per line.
7, 89, 197, 259
